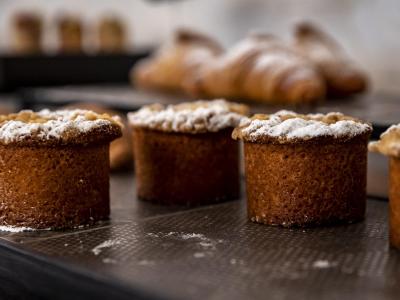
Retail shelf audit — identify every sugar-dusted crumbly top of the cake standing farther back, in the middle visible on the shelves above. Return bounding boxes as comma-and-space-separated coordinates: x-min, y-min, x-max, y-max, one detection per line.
128, 100, 248, 133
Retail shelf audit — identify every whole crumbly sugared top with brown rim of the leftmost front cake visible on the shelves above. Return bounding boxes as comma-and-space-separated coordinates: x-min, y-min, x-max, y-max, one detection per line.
0, 109, 122, 145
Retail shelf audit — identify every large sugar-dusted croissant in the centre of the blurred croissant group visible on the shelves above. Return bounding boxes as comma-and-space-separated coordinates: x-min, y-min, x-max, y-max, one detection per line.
186, 34, 325, 104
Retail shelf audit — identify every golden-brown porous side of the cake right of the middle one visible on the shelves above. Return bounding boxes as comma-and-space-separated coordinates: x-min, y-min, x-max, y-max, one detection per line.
244, 135, 368, 227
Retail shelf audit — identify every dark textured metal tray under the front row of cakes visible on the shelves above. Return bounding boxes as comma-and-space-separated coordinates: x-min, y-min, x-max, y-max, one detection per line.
0, 174, 400, 300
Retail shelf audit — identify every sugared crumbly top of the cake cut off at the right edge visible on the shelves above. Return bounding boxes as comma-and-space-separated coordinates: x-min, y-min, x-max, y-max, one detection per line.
368, 124, 400, 157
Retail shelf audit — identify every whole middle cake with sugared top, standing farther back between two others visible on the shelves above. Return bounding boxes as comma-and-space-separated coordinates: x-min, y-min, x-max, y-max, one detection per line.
128, 100, 247, 206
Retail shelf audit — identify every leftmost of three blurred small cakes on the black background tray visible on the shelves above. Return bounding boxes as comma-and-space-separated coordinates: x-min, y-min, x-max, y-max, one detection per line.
12, 12, 43, 54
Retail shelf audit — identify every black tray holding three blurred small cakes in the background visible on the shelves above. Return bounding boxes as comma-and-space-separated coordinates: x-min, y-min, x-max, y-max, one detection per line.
0, 49, 150, 91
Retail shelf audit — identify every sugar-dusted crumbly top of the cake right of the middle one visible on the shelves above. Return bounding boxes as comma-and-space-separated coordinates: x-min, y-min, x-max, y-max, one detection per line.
232, 110, 372, 144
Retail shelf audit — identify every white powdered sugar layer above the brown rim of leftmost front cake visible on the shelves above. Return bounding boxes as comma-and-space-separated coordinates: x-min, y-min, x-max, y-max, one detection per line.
0, 109, 120, 143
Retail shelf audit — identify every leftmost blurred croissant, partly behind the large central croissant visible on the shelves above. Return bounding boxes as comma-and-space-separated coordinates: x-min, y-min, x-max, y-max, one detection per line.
131, 29, 222, 92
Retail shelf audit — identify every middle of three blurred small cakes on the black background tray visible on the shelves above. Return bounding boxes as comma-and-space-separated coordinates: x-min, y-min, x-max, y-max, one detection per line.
57, 15, 83, 53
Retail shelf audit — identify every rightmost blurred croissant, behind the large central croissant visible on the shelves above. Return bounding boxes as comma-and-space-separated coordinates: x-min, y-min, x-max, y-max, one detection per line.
294, 22, 368, 96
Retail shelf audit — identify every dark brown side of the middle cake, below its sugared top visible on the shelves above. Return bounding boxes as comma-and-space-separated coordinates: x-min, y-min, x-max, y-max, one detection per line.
133, 127, 239, 206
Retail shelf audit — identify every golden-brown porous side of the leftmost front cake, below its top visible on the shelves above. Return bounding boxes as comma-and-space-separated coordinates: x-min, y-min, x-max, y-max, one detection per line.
0, 143, 110, 229
